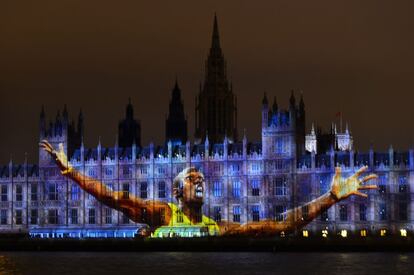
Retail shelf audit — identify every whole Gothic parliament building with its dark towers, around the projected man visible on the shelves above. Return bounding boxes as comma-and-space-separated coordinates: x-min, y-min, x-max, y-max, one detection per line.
0, 17, 414, 238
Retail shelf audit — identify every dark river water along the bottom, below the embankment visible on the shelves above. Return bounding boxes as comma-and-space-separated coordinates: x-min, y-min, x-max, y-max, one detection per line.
0, 252, 414, 275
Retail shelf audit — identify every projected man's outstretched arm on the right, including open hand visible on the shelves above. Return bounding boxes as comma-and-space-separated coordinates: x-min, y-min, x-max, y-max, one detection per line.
227, 166, 377, 235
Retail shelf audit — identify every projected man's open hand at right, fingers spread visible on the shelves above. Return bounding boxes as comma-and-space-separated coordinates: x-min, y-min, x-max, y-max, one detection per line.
331, 166, 378, 201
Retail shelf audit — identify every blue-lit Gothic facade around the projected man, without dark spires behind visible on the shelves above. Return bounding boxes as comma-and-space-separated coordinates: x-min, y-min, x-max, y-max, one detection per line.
0, 94, 414, 237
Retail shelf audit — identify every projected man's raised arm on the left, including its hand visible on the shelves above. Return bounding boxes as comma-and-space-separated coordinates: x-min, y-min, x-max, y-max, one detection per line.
39, 140, 171, 229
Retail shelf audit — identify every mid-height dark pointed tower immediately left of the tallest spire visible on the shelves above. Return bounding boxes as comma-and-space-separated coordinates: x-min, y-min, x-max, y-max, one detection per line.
165, 80, 187, 144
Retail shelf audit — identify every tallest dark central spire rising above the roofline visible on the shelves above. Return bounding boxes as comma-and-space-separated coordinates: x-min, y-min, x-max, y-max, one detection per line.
195, 15, 237, 143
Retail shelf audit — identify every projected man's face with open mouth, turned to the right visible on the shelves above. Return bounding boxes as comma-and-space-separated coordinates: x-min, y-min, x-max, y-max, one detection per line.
182, 172, 204, 205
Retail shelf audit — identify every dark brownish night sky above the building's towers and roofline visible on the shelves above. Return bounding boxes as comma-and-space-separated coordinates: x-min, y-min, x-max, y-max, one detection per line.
0, 0, 414, 164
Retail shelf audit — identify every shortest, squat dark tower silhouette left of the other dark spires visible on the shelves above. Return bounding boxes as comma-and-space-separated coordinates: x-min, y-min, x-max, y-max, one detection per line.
118, 98, 141, 147
